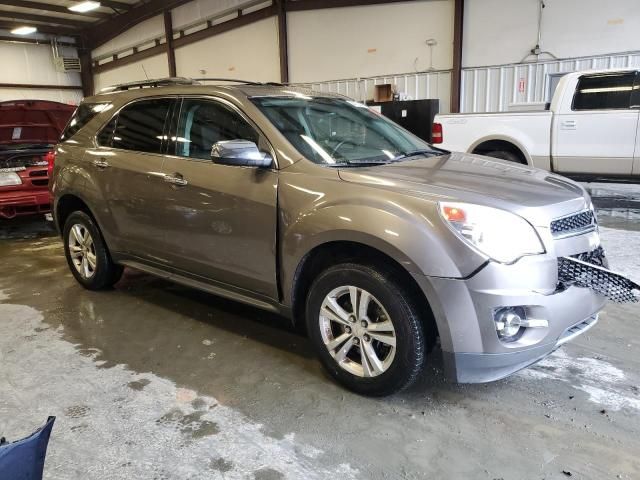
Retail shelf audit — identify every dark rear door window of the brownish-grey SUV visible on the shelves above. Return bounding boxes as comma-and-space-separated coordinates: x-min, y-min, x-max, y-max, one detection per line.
112, 98, 171, 153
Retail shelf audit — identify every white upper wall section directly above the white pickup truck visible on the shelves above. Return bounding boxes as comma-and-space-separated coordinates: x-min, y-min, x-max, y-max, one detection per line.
463, 0, 640, 67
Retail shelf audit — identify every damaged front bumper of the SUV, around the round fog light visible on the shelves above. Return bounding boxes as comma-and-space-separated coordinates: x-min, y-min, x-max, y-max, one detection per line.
414, 251, 606, 383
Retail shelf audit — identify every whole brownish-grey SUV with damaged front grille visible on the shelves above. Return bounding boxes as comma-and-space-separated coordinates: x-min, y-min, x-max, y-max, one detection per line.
51, 79, 628, 395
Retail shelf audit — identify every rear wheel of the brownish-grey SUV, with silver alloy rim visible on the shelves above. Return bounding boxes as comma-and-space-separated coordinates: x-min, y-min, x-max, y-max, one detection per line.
63, 211, 123, 290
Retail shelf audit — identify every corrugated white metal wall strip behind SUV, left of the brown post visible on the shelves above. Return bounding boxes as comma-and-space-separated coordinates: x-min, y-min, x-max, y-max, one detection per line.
304, 70, 451, 112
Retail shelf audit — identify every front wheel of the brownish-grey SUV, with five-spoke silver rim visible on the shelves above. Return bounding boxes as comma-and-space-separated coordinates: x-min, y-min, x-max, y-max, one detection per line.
306, 264, 426, 396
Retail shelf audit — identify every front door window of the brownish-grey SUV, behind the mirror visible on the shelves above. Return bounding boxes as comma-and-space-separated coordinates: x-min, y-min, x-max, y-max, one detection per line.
175, 99, 260, 160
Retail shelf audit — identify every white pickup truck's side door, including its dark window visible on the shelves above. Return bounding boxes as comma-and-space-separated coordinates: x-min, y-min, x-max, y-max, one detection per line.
553, 72, 638, 175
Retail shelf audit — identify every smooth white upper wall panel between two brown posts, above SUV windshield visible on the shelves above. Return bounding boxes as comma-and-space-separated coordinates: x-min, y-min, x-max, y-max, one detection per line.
287, 0, 453, 82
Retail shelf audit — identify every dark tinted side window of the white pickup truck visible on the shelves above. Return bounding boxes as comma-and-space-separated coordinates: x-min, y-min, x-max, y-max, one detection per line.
572, 73, 635, 110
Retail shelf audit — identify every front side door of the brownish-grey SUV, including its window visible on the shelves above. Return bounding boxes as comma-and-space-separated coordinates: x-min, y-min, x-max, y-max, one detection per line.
162, 98, 278, 298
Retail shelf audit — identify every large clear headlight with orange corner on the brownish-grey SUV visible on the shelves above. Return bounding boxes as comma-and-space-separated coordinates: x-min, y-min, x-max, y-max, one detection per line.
440, 202, 545, 263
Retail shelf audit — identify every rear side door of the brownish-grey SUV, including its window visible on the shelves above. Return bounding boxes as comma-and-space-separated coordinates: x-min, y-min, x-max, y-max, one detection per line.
85, 98, 175, 262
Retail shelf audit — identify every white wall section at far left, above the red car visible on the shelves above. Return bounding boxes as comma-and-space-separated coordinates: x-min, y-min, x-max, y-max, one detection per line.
0, 42, 82, 103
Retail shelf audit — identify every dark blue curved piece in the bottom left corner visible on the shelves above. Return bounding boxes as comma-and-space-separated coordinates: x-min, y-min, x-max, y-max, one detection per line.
0, 417, 56, 480
